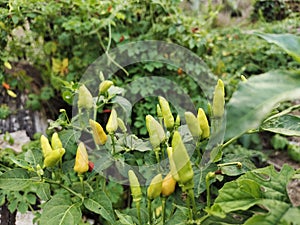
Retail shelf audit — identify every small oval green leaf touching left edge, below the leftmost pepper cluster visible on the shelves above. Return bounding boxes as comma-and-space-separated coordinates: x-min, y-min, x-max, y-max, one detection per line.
0, 168, 32, 191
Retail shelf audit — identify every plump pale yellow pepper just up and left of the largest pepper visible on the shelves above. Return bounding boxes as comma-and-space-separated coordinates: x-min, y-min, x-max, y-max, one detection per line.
146, 115, 166, 149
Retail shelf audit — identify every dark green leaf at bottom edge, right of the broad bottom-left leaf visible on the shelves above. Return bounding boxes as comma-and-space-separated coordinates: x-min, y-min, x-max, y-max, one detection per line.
83, 191, 115, 224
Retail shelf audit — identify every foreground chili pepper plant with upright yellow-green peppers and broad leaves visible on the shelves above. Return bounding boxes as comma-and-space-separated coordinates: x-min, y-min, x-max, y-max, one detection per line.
0, 33, 300, 225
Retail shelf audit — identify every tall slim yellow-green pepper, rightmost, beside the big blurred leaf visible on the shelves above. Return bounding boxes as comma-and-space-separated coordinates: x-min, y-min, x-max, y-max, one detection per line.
212, 79, 225, 117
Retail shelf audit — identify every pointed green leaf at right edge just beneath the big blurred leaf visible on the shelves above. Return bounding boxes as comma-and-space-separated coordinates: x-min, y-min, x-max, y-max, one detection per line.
261, 115, 300, 136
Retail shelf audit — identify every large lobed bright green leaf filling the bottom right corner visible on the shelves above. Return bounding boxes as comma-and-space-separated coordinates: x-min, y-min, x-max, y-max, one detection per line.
209, 165, 300, 225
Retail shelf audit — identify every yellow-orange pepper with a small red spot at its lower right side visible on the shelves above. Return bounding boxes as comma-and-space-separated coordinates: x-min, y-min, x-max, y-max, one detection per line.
74, 142, 89, 174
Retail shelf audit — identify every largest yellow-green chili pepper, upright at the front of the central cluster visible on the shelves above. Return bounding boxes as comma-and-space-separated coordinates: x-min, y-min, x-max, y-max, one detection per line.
172, 131, 194, 191
